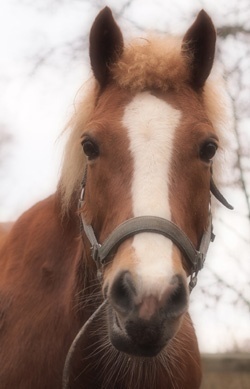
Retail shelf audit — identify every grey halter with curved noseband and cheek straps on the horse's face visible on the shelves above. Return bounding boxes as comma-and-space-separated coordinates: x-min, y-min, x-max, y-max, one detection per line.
78, 168, 233, 291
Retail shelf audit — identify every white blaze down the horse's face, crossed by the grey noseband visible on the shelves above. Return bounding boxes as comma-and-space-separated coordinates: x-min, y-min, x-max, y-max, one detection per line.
123, 92, 181, 296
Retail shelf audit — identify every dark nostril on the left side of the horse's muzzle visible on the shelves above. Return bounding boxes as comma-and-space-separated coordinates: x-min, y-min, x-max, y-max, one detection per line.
109, 271, 136, 314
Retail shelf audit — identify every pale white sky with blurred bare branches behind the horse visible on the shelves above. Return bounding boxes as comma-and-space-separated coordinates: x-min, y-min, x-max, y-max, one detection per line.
0, 0, 250, 374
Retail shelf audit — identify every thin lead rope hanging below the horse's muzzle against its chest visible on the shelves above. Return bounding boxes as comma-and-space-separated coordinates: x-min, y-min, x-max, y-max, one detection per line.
62, 299, 108, 389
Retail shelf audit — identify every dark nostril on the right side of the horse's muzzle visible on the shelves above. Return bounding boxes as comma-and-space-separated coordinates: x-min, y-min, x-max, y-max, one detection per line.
165, 275, 188, 317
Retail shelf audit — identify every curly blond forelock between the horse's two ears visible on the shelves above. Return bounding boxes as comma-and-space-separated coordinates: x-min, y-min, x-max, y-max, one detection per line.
111, 36, 190, 91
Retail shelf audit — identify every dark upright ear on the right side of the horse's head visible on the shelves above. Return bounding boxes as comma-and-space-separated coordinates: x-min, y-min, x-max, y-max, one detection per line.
182, 10, 216, 90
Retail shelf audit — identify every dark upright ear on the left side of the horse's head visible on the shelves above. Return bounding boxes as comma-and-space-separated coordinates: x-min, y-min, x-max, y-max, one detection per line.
89, 7, 123, 87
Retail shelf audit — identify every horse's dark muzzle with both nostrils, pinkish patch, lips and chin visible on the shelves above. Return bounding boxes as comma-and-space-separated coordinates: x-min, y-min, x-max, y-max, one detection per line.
108, 271, 188, 357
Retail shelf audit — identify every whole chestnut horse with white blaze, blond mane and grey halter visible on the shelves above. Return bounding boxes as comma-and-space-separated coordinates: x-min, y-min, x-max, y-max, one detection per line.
0, 7, 230, 389
